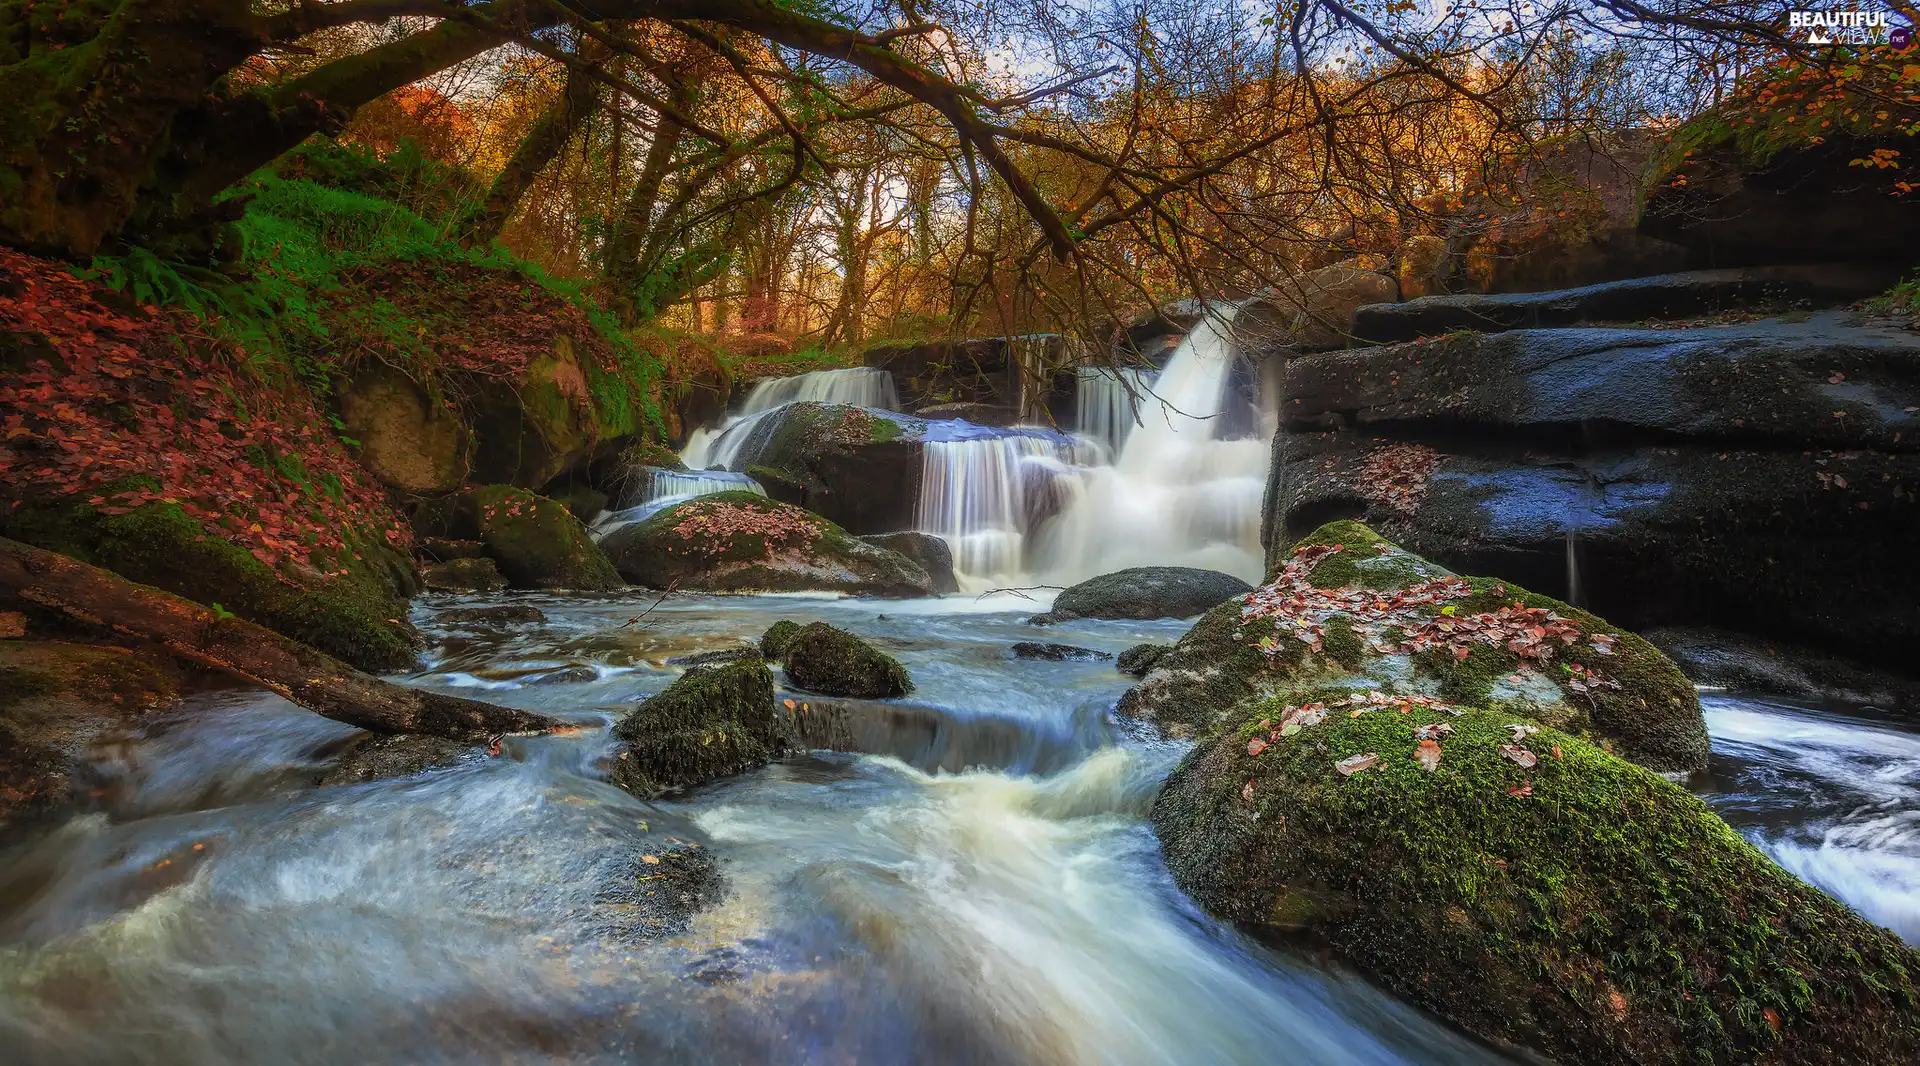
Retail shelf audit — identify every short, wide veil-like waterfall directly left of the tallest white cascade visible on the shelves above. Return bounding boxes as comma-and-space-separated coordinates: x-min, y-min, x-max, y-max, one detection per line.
914, 434, 1089, 592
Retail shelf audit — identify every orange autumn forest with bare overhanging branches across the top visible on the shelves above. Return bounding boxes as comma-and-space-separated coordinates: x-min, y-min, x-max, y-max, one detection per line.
15, 0, 1920, 368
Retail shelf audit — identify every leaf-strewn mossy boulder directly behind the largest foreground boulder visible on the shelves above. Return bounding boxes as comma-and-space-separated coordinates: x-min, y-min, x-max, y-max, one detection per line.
1119, 521, 1707, 772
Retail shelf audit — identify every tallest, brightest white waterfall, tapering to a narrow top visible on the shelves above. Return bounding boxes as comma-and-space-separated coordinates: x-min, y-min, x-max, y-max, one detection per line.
1031, 307, 1269, 584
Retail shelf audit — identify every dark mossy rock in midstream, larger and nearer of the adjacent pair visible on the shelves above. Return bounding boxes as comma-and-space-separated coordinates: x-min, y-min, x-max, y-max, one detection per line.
612, 657, 787, 799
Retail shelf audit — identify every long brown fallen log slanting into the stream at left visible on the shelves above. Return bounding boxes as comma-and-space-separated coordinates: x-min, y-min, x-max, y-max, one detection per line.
0, 538, 559, 741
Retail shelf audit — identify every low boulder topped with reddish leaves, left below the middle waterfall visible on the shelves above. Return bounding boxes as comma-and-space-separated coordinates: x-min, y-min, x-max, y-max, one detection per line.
601, 492, 933, 597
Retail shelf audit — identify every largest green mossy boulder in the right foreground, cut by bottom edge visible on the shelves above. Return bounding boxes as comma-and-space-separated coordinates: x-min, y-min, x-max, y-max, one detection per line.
1154, 688, 1920, 1066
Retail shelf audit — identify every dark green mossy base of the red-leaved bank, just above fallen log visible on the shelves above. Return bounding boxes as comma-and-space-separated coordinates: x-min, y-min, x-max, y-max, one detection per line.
0, 503, 420, 672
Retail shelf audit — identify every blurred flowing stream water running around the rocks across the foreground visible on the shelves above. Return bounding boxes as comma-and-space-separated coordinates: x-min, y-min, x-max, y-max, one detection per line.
0, 592, 1920, 1066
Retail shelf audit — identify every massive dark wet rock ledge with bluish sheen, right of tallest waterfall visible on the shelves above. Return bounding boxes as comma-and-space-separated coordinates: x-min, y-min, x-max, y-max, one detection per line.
1263, 315, 1920, 666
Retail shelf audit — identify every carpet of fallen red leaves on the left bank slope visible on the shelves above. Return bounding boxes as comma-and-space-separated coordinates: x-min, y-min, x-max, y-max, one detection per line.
0, 250, 411, 570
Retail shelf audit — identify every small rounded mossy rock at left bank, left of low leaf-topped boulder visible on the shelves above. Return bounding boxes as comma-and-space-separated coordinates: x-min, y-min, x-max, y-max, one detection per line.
468, 484, 624, 590
